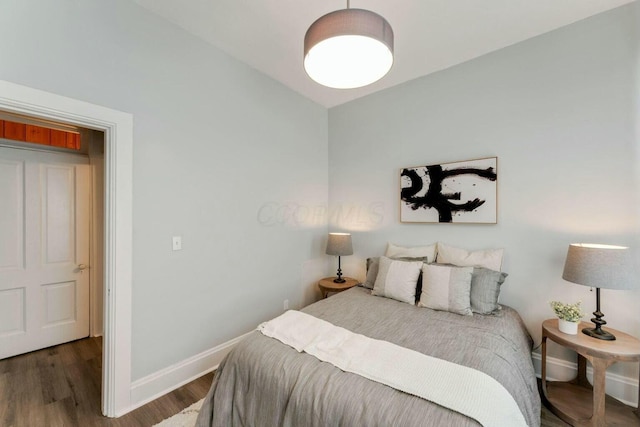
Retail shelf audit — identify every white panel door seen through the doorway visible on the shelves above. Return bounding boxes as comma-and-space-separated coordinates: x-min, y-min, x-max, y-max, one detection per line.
0, 147, 91, 359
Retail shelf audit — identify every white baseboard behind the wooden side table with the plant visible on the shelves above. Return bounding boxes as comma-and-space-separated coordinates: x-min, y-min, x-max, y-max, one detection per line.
531, 353, 638, 407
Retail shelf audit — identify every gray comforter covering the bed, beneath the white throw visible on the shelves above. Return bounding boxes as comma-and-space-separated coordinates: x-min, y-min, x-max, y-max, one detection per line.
196, 288, 540, 427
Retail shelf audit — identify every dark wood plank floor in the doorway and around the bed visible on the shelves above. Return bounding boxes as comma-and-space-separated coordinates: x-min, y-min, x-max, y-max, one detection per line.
0, 338, 568, 427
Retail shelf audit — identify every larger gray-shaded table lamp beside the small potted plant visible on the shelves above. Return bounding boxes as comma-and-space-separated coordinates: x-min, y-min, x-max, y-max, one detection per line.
562, 243, 636, 340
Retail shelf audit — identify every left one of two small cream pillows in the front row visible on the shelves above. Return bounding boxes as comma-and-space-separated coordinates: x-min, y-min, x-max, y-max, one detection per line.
371, 257, 423, 304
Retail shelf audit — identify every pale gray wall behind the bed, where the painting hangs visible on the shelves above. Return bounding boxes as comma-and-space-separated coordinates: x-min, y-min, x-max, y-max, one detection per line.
329, 2, 640, 378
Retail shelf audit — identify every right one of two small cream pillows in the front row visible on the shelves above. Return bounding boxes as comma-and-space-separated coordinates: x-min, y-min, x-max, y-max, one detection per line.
418, 264, 473, 316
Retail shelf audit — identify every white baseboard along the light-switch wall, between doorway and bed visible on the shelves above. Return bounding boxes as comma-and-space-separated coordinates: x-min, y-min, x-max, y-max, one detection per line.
126, 332, 250, 412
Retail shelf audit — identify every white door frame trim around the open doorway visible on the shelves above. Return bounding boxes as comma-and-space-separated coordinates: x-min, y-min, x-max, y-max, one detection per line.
0, 80, 133, 417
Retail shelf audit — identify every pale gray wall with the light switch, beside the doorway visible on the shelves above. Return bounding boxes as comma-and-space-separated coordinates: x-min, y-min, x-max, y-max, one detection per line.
0, 0, 328, 380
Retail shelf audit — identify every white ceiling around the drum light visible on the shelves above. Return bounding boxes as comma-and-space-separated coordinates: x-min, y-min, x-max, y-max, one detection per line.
134, 0, 633, 107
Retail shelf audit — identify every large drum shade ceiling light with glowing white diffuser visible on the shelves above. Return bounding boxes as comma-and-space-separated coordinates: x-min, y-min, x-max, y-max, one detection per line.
304, 1, 393, 89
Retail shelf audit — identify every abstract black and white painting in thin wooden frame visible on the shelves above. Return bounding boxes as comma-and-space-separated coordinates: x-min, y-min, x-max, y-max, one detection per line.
400, 157, 498, 224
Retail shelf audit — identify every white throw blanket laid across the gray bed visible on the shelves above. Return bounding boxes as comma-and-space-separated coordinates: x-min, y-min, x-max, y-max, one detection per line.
258, 310, 527, 427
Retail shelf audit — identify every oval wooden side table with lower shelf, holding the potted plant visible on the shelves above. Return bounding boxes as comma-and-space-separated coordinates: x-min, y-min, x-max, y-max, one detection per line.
542, 319, 640, 427
